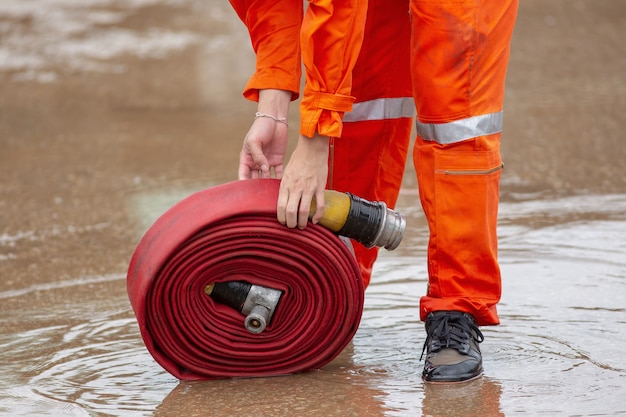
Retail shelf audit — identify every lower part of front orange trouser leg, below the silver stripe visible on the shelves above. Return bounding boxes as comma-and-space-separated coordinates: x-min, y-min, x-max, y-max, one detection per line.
413, 135, 502, 325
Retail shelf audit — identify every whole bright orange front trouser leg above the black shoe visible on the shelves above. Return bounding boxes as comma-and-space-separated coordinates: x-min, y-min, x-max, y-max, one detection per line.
411, 0, 517, 325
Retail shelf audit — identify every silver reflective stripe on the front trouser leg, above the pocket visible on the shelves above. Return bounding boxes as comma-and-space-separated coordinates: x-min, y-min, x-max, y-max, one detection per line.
415, 111, 503, 145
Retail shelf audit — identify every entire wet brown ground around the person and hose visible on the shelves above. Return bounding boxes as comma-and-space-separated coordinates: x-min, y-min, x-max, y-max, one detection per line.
0, 0, 626, 416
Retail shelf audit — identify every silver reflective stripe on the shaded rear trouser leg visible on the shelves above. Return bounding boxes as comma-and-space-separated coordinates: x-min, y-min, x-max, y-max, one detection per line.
343, 97, 415, 123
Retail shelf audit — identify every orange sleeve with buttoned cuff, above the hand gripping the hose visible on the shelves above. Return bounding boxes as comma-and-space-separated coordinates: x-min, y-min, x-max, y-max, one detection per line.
300, 0, 367, 137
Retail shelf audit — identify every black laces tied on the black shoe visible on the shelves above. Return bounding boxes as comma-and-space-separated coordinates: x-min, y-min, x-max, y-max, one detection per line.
420, 312, 485, 361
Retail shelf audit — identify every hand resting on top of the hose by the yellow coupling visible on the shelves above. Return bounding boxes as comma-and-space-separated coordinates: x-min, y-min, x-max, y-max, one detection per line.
276, 134, 329, 229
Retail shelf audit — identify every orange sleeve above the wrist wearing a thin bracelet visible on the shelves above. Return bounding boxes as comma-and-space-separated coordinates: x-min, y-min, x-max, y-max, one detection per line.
230, 0, 303, 101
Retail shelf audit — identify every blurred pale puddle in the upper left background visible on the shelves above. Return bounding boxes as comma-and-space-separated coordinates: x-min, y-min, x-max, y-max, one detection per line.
0, 0, 250, 84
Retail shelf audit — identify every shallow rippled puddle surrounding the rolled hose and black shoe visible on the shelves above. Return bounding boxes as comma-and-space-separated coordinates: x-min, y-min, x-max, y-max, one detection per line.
0, 193, 626, 416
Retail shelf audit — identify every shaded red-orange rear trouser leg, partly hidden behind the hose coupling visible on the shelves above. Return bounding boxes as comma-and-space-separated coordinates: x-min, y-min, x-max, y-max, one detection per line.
328, 0, 414, 285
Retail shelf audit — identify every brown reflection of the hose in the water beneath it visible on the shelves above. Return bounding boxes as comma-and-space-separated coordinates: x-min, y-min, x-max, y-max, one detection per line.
154, 349, 385, 417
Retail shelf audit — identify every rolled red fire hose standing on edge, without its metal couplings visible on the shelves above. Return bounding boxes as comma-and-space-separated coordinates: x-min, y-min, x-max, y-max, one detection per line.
127, 179, 364, 379
